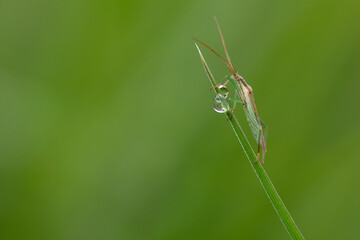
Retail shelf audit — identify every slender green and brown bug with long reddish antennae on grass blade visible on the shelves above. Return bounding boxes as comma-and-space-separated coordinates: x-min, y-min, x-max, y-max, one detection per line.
194, 17, 268, 165
